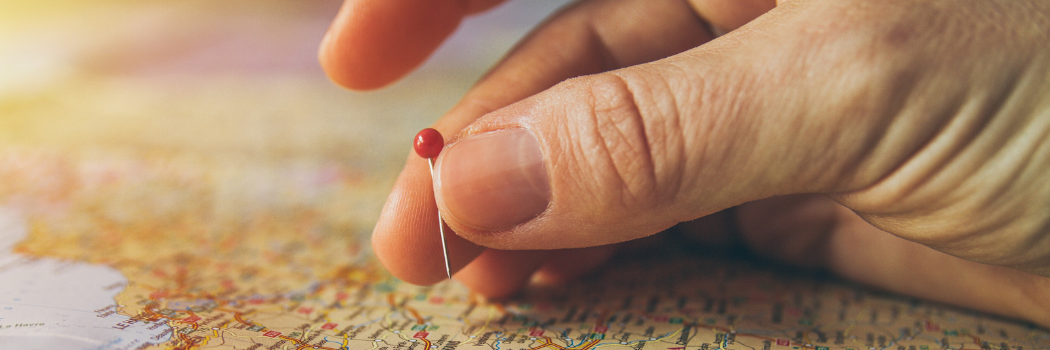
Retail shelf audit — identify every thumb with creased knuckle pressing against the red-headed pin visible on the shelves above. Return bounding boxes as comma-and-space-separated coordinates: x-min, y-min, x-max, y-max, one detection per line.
435, 3, 943, 249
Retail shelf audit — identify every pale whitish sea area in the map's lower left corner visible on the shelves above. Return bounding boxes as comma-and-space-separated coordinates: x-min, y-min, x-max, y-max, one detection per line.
0, 206, 171, 349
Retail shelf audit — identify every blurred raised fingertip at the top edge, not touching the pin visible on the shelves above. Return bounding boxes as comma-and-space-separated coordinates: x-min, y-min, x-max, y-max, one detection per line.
318, 0, 469, 90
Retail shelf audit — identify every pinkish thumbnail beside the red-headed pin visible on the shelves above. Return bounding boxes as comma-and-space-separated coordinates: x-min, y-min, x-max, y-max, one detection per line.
437, 129, 550, 231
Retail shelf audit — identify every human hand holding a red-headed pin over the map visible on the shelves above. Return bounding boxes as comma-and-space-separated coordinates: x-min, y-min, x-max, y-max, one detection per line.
321, 0, 1050, 325
